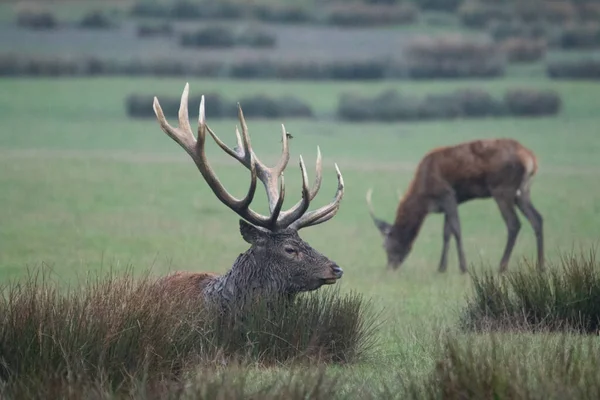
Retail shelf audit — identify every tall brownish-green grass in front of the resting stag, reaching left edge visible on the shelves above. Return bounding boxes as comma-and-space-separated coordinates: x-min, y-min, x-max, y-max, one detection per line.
0, 273, 375, 393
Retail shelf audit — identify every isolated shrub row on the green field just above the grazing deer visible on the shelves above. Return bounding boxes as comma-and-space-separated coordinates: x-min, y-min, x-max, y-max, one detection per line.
337, 89, 561, 122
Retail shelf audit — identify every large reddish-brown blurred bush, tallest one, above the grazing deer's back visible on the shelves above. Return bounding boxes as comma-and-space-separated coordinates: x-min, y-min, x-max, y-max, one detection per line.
405, 36, 505, 79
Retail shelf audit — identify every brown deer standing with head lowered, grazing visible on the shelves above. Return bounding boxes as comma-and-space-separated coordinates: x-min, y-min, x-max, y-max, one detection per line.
367, 139, 544, 273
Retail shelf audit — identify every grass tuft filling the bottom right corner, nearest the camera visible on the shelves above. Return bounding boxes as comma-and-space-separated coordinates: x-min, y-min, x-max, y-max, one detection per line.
404, 334, 600, 400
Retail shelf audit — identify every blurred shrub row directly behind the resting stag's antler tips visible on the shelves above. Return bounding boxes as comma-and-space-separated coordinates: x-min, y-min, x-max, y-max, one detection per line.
125, 93, 313, 118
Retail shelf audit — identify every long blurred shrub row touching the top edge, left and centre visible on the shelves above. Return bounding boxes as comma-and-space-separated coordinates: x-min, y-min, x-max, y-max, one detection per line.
131, 1, 418, 26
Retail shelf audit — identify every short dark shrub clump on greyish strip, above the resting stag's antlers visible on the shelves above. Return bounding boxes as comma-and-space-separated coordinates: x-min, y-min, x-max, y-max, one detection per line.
180, 25, 276, 48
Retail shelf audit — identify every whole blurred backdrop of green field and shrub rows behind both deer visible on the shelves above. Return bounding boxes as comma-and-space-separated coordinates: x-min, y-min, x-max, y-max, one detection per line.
0, 0, 600, 398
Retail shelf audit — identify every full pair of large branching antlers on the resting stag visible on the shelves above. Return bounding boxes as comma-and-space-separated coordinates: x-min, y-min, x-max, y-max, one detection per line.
153, 83, 344, 231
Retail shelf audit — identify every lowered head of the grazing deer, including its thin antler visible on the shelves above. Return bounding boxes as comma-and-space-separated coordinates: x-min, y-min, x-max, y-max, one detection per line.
367, 189, 413, 269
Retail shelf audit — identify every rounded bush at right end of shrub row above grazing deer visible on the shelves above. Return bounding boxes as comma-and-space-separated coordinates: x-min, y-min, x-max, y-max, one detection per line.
504, 89, 562, 117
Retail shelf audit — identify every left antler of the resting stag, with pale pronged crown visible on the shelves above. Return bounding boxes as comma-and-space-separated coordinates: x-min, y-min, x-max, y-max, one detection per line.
153, 83, 266, 225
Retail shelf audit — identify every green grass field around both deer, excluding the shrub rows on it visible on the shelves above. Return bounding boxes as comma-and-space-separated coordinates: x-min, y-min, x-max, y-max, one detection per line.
0, 78, 600, 393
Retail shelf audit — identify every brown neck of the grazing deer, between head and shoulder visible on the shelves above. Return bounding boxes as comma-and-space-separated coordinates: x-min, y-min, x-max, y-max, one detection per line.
392, 192, 429, 246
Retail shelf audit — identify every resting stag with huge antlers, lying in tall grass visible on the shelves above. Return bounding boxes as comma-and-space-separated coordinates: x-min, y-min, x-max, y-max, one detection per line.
153, 84, 344, 309
